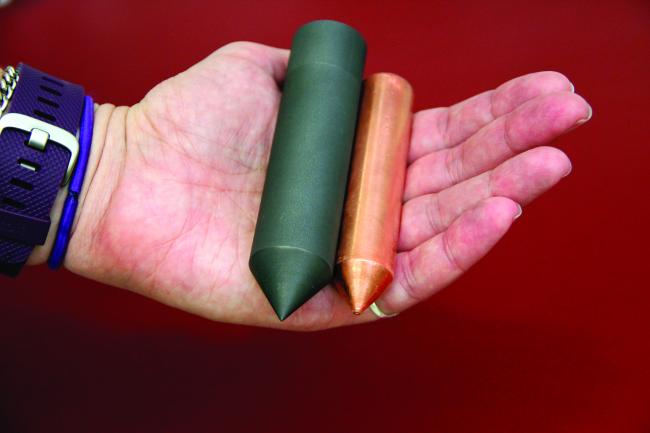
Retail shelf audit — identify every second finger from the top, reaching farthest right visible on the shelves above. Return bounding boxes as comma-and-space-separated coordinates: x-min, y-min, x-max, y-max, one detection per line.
404, 92, 591, 200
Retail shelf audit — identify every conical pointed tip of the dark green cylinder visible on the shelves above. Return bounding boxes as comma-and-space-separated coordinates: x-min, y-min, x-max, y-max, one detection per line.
249, 247, 332, 321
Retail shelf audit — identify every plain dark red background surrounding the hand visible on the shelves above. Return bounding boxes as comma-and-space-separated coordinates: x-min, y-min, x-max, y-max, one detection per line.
0, 0, 650, 433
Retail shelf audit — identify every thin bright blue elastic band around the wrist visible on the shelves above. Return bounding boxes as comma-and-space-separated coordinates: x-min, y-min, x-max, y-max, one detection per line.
47, 96, 95, 269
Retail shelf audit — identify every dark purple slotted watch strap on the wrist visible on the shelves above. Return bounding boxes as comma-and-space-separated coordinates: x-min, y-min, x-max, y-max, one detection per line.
0, 64, 84, 276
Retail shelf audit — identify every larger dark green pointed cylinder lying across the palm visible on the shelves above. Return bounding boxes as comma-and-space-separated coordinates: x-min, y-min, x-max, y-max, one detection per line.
249, 21, 366, 320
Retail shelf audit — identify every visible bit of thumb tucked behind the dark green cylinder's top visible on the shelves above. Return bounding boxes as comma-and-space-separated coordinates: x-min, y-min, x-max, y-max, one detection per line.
217, 41, 289, 83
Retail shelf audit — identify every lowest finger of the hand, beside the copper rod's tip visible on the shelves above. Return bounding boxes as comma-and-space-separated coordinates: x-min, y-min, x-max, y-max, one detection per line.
377, 197, 519, 313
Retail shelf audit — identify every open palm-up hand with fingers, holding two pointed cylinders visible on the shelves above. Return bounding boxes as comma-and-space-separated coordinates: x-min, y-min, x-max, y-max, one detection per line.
36, 42, 591, 330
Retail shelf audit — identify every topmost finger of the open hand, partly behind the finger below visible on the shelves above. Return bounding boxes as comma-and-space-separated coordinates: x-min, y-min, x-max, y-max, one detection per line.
409, 71, 573, 162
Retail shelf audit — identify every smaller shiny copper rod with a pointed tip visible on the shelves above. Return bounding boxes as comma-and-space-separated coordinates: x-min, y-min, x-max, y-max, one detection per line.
336, 73, 413, 314
